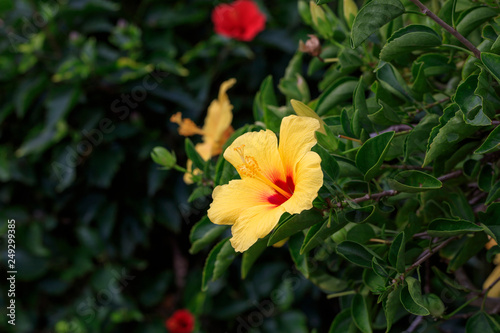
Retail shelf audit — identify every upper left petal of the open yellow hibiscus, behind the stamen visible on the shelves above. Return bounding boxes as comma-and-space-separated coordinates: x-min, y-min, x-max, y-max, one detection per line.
224, 130, 286, 182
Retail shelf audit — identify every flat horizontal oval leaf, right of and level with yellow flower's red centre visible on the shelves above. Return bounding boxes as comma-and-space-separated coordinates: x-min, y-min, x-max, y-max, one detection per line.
387, 170, 443, 193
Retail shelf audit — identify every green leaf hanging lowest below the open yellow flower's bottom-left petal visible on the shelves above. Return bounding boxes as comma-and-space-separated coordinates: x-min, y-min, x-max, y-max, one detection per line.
201, 237, 236, 291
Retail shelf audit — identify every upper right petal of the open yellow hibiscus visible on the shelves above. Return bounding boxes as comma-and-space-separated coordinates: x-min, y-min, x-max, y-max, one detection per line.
279, 116, 320, 175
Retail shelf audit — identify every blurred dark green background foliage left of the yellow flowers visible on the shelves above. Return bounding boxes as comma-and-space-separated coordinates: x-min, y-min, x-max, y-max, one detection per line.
0, 0, 331, 333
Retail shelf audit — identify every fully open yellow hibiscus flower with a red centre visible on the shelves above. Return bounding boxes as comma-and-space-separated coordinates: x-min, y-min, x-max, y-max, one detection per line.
208, 116, 323, 252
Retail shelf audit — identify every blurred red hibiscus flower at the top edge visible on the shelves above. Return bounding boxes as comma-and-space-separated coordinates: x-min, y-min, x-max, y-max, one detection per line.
212, 0, 266, 42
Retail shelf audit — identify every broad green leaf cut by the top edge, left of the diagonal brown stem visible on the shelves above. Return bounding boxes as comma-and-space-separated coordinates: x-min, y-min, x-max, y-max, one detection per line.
351, 0, 405, 48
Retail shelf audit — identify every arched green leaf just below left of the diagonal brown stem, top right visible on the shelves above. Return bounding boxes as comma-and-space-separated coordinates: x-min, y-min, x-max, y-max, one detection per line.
380, 24, 441, 61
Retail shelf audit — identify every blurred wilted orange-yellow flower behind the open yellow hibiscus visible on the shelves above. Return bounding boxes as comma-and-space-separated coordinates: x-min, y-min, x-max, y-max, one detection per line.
170, 79, 236, 184
